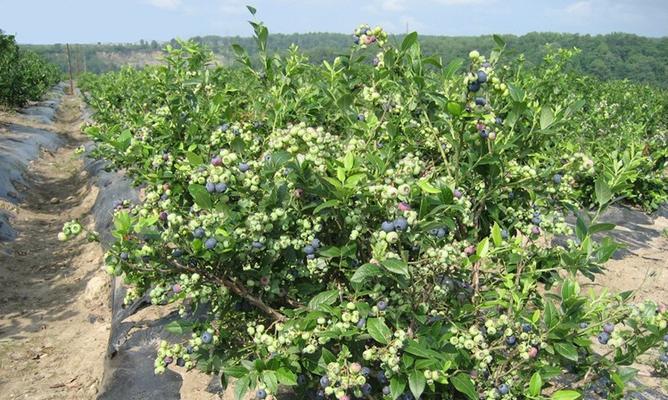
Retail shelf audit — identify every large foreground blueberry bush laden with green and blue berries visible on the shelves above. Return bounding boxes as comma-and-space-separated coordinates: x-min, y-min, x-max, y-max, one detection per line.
75, 8, 668, 400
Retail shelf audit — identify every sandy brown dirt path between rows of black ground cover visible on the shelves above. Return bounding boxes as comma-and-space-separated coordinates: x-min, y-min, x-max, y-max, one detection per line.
0, 96, 110, 400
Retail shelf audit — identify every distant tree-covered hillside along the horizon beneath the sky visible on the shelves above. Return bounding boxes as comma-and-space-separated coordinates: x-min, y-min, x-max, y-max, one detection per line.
27, 33, 668, 87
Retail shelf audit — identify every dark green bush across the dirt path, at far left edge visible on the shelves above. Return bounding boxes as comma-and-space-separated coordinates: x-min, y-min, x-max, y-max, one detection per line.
0, 31, 60, 107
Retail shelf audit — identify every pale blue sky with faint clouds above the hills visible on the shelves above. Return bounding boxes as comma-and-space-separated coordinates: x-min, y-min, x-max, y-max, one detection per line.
0, 0, 668, 44
